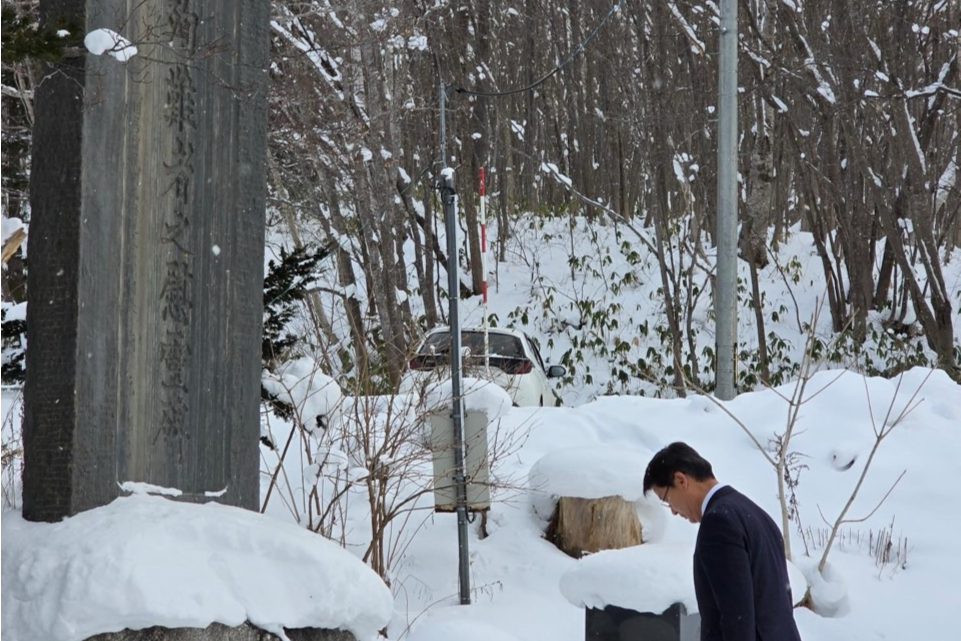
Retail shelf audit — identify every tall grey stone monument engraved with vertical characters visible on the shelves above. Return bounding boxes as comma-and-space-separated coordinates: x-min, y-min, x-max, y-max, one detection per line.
23, 0, 269, 520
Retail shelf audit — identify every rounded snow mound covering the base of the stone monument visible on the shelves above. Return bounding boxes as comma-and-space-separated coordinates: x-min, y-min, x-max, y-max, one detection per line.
0, 495, 393, 641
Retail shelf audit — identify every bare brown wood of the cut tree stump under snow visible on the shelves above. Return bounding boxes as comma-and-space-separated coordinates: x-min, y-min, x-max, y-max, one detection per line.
546, 496, 644, 559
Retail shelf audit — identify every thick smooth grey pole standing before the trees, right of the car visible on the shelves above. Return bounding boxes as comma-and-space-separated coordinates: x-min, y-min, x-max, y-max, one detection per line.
714, 0, 737, 401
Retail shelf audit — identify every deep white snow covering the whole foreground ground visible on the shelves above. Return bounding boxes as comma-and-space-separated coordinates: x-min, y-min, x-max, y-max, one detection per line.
2, 368, 961, 641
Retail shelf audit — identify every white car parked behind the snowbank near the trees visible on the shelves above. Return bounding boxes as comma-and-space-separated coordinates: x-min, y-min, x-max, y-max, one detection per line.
399, 327, 567, 407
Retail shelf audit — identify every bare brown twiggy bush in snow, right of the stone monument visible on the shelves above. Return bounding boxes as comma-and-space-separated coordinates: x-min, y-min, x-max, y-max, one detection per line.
261, 358, 523, 585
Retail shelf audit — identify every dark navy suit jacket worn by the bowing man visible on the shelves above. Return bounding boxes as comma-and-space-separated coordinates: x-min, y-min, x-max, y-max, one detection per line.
694, 487, 801, 641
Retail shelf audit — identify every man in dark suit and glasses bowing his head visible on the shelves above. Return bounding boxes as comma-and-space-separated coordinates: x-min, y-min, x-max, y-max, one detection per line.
644, 443, 801, 641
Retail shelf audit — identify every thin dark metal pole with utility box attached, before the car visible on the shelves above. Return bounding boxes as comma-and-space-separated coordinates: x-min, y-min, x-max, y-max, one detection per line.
437, 76, 470, 605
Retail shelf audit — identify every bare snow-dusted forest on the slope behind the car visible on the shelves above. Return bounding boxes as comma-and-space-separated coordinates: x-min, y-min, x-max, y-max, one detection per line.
2, 0, 961, 396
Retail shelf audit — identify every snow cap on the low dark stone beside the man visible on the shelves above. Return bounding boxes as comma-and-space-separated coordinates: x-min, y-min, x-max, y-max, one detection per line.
560, 543, 697, 614
